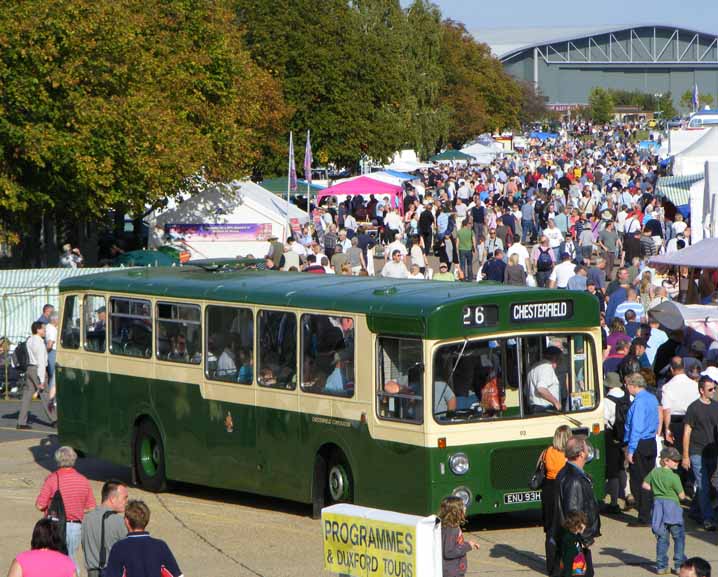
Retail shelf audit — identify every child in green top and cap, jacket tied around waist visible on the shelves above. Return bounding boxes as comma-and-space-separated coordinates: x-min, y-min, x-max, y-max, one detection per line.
643, 447, 686, 575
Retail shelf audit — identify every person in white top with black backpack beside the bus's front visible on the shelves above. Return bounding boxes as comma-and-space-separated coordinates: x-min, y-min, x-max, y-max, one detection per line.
603, 372, 631, 515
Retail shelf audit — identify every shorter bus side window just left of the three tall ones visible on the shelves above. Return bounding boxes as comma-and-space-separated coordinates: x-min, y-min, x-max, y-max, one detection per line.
156, 302, 202, 365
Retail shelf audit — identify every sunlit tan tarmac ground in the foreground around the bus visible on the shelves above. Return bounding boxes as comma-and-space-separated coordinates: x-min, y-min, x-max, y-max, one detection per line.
0, 430, 718, 577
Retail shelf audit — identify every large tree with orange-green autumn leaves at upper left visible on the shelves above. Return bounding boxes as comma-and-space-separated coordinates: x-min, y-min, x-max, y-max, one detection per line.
0, 0, 286, 264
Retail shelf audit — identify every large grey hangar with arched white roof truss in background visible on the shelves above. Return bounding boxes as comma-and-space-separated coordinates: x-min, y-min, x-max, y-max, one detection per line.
474, 25, 718, 112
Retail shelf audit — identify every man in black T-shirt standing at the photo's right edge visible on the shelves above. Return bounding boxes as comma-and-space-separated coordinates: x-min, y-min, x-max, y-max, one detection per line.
682, 367, 718, 531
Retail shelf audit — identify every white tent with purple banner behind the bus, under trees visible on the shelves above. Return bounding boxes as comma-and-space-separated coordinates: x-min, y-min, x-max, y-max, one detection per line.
150, 180, 309, 258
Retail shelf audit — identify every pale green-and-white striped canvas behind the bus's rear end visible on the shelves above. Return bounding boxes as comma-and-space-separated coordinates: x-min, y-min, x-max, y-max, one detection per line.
0, 268, 112, 398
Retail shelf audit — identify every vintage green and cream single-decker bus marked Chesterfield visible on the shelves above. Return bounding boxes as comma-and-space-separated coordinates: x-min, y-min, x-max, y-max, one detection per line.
58, 266, 604, 515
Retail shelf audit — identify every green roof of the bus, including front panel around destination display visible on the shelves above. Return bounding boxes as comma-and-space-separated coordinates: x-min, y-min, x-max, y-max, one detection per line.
60, 267, 599, 339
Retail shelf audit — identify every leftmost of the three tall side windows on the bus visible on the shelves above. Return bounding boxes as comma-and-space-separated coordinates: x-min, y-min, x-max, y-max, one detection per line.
205, 305, 254, 385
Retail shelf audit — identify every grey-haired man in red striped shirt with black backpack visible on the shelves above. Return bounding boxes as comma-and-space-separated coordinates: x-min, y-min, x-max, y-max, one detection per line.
35, 447, 96, 574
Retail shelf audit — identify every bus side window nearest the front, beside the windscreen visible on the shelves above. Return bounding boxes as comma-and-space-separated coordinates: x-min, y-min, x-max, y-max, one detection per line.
376, 337, 424, 423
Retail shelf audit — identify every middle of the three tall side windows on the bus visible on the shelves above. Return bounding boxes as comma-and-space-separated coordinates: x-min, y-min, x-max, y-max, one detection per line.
257, 311, 297, 390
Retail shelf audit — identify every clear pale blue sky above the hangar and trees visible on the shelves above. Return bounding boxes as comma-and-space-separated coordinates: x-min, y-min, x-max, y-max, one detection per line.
402, 0, 718, 35
